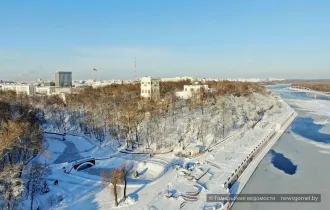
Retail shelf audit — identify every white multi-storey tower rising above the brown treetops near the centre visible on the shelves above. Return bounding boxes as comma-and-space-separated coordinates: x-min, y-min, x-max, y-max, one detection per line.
140, 77, 160, 99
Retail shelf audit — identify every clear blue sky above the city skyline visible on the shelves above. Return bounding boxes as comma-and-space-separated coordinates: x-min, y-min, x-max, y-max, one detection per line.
0, 0, 330, 80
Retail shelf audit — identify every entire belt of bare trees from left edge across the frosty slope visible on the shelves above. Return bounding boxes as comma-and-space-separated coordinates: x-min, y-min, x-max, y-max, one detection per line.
0, 81, 273, 209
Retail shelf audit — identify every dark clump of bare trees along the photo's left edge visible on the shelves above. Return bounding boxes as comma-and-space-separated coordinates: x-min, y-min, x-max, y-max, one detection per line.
0, 91, 43, 209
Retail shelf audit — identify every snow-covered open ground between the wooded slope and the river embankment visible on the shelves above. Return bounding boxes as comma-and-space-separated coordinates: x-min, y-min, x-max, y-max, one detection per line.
28, 91, 292, 210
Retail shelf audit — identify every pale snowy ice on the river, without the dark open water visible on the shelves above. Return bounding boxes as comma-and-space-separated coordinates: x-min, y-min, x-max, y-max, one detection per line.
233, 86, 330, 210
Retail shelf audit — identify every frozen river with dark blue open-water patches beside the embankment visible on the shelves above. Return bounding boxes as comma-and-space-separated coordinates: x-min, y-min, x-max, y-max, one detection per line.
232, 86, 330, 210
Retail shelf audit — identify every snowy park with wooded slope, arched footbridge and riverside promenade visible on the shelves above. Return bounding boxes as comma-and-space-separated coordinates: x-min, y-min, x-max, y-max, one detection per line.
0, 83, 302, 210
